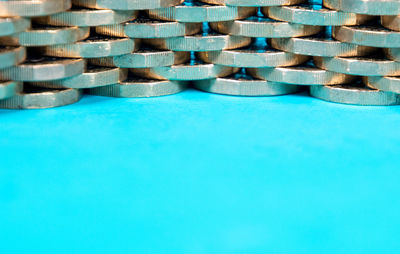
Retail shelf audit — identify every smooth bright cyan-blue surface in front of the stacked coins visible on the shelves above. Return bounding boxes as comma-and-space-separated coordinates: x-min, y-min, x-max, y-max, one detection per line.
0, 90, 400, 254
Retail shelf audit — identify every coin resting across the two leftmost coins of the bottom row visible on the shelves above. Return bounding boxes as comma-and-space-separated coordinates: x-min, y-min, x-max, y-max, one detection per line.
32, 65, 128, 88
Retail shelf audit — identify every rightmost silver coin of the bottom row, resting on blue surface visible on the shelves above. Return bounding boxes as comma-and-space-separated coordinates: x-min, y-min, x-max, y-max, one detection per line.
310, 85, 400, 106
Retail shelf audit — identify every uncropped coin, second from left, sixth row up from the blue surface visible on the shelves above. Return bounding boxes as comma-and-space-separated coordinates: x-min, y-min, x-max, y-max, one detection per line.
35, 7, 138, 27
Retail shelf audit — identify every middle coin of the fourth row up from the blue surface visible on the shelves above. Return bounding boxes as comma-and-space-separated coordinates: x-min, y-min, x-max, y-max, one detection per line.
143, 34, 251, 51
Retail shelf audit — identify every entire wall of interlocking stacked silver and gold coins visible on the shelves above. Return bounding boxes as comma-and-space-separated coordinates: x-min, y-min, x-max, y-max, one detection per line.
0, 0, 400, 108
